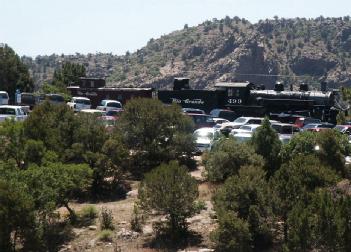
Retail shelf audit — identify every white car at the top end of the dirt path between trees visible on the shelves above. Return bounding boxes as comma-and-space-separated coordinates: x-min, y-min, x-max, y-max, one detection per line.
193, 127, 219, 153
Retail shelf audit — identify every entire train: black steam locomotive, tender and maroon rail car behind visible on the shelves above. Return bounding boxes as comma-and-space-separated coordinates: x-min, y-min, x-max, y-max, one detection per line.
20, 77, 349, 123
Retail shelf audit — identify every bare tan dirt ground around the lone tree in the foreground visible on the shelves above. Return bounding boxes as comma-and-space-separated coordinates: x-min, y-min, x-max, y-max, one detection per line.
60, 157, 216, 252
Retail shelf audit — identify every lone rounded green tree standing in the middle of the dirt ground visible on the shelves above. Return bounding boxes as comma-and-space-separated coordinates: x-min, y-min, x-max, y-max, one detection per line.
138, 161, 198, 238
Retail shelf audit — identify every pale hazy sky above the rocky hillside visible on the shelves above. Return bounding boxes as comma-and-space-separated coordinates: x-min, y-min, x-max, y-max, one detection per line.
0, 0, 351, 56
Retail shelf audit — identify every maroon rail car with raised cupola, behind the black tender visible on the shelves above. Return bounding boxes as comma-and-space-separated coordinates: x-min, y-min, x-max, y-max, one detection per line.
67, 78, 154, 108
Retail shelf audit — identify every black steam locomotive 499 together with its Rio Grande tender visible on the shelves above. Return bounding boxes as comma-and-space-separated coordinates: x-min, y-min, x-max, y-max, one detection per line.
158, 78, 347, 122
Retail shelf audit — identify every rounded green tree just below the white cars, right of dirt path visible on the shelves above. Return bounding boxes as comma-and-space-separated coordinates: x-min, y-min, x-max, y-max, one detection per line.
205, 138, 263, 182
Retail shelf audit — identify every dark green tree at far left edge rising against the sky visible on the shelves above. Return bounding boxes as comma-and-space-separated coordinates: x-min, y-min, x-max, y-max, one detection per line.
0, 45, 34, 98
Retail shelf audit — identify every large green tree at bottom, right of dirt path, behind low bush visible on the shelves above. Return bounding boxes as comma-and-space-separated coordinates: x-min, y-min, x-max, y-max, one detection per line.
214, 166, 273, 248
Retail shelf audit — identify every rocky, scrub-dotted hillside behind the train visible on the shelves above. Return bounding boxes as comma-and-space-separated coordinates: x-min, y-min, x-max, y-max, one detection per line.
22, 16, 351, 88
